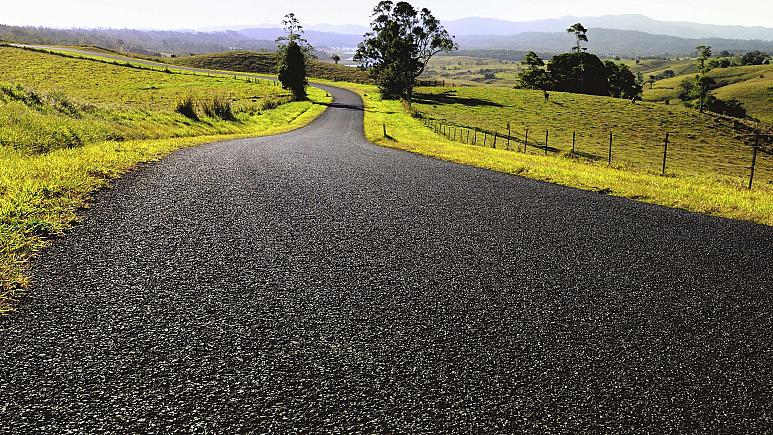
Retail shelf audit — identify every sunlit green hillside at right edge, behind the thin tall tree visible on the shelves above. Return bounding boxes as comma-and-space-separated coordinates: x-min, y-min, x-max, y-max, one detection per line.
644, 65, 773, 124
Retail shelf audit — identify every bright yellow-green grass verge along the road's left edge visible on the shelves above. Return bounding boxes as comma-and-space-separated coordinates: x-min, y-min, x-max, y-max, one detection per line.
0, 92, 330, 314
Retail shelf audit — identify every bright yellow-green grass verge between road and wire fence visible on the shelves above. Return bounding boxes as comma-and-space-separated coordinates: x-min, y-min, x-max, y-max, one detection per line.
316, 82, 773, 225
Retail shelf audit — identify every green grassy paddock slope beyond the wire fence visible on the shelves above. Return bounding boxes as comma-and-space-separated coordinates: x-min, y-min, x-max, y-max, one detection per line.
414, 87, 773, 182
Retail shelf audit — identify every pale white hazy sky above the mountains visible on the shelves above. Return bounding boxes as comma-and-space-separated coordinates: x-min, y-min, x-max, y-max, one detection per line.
0, 0, 773, 29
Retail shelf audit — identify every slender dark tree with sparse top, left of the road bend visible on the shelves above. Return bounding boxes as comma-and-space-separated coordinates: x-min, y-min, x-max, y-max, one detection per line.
276, 13, 311, 100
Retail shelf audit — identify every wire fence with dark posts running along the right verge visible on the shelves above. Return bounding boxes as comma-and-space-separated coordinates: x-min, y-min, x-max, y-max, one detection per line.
420, 114, 773, 189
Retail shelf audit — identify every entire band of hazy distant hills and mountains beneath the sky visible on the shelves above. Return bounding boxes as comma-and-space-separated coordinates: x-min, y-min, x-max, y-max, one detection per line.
0, 15, 773, 57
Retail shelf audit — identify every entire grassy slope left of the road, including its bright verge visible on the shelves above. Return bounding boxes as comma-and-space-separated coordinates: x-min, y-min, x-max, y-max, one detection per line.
0, 49, 329, 313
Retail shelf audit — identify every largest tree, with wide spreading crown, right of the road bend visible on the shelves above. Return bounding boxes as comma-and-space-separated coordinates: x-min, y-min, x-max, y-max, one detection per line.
354, 0, 458, 104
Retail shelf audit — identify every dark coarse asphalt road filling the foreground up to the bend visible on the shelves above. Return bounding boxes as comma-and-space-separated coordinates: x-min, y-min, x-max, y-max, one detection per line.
0, 85, 773, 433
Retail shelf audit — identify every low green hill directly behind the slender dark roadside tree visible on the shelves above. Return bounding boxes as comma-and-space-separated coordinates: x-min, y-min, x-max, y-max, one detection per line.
165, 51, 370, 83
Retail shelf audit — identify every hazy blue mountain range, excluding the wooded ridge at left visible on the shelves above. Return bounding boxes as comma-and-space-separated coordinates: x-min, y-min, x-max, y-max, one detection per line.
238, 15, 773, 56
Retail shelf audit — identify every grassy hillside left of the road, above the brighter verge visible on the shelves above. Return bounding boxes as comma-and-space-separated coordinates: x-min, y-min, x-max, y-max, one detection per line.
0, 47, 328, 153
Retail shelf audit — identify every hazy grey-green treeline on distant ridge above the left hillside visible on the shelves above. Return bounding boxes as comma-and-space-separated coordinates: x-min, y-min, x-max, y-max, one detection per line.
0, 24, 276, 56
